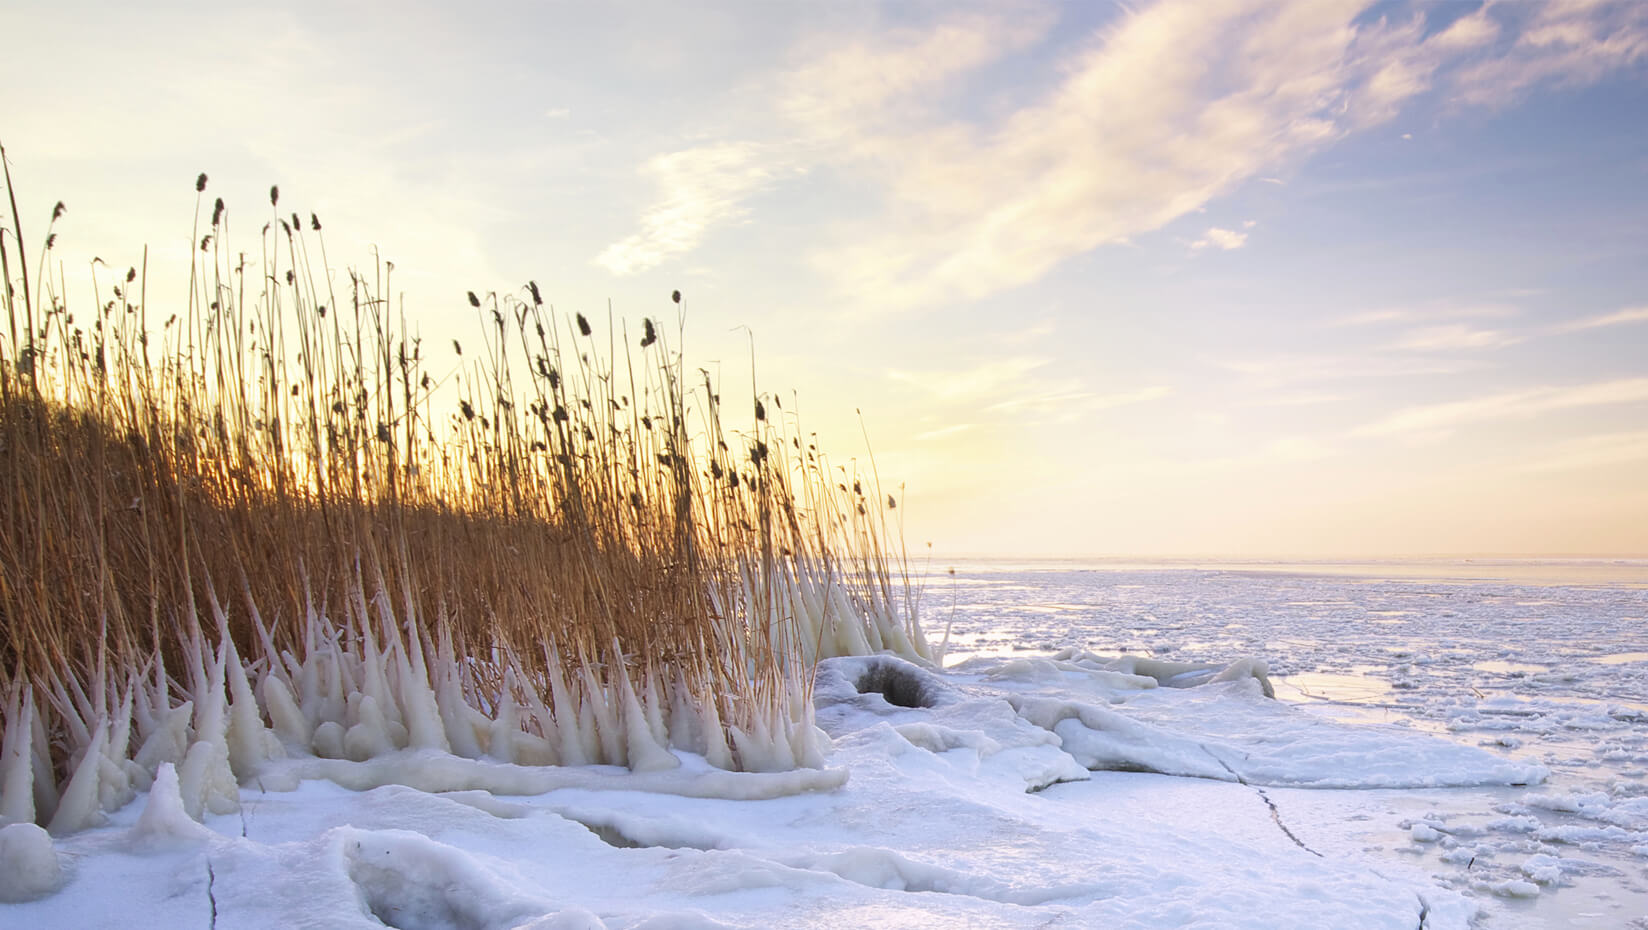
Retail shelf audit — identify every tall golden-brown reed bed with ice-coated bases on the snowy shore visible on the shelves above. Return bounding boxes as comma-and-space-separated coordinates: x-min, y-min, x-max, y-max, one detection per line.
0, 150, 931, 833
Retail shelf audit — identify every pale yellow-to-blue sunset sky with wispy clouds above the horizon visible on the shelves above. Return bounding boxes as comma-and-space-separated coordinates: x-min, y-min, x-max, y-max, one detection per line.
0, 0, 1648, 559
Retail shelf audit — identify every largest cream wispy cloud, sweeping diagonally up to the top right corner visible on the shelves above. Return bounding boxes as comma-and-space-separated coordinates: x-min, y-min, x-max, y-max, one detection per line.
602, 0, 1648, 308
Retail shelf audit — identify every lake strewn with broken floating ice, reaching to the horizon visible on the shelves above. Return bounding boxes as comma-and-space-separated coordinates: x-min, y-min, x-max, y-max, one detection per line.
925, 561, 1648, 928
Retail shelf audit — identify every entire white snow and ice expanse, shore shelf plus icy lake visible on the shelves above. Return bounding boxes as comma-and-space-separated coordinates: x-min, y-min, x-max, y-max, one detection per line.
0, 566, 1648, 930
